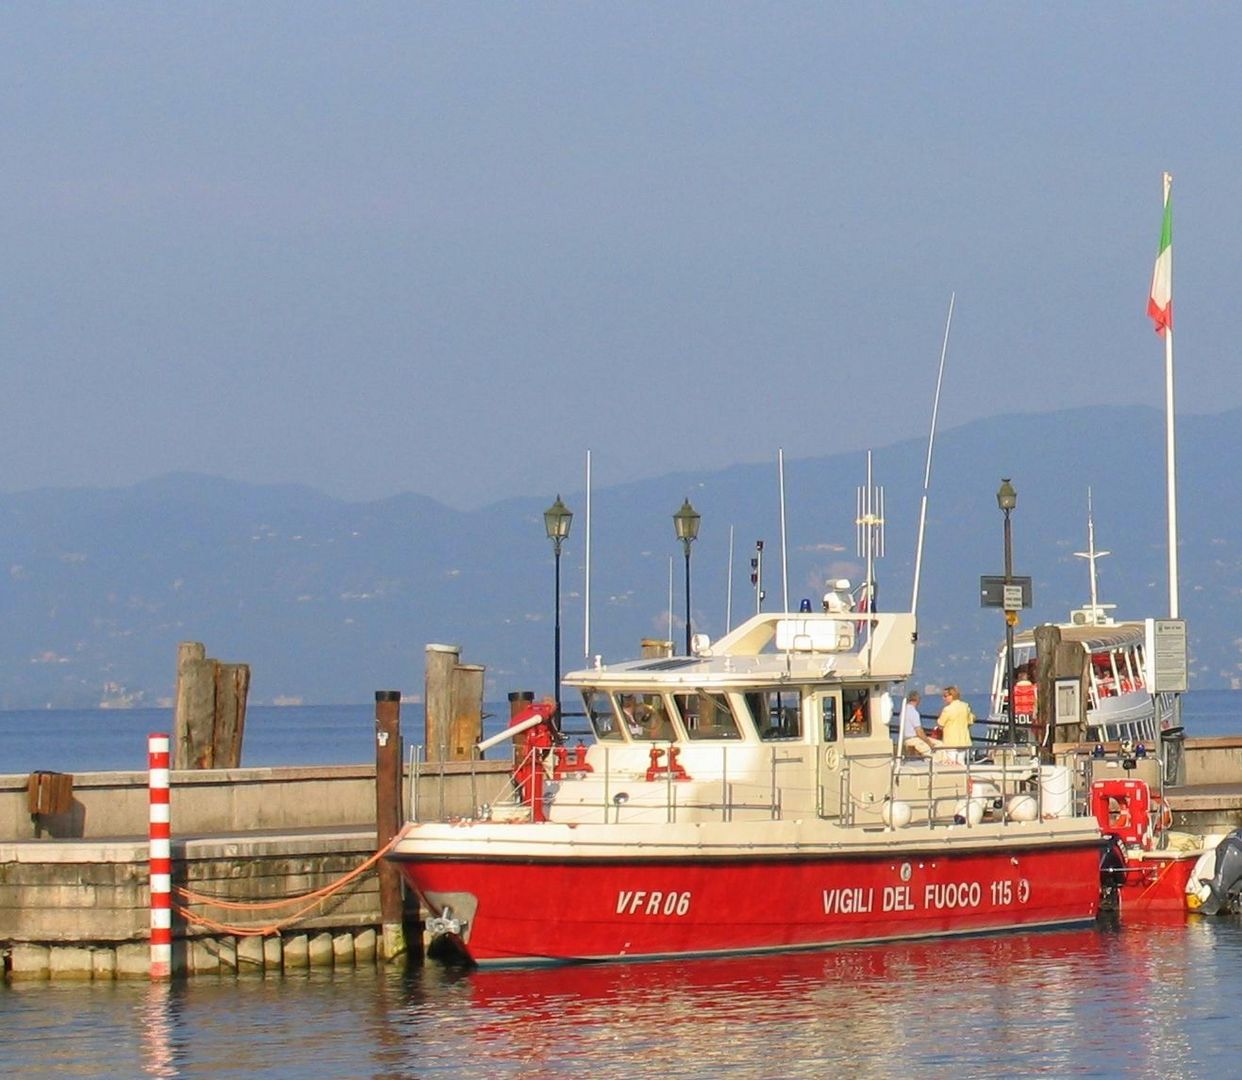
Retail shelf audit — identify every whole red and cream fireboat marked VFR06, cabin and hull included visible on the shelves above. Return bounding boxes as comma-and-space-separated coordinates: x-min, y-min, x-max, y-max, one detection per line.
389, 605, 1104, 965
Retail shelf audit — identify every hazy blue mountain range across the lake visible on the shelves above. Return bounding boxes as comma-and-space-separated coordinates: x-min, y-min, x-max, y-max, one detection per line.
0, 402, 1242, 709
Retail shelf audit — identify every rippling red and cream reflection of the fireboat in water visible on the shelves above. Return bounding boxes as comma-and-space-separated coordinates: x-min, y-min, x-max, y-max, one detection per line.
397, 915, 1222, 1076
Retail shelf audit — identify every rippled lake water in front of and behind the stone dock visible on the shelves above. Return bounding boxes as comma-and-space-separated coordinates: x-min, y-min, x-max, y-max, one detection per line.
7, 691, 1242, 1078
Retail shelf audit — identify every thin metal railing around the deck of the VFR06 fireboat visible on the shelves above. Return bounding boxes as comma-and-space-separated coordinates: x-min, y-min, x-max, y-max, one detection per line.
409, 744, 1082, 829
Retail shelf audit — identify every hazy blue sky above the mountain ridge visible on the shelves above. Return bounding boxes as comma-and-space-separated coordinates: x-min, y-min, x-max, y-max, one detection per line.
0, 2, 1242, 508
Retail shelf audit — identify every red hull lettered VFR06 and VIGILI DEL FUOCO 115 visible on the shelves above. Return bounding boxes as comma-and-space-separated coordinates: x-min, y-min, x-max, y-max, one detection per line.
390, 842, 1100, 963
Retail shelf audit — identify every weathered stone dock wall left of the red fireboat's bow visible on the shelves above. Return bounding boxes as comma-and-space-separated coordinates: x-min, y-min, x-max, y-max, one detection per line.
0, 761, 509, 979
